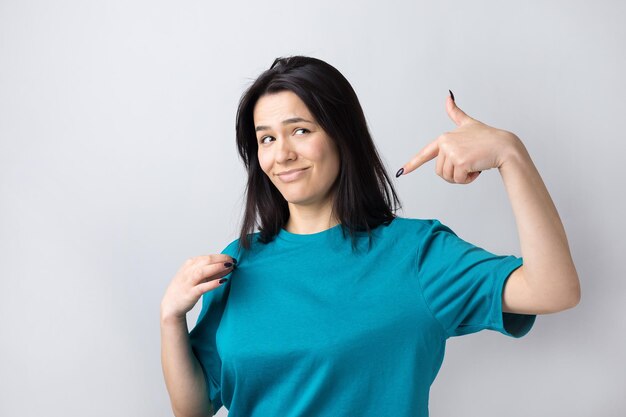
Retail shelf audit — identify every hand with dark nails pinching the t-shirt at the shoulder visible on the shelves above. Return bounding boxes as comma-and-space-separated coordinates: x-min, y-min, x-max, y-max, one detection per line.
161, 254, 236, 319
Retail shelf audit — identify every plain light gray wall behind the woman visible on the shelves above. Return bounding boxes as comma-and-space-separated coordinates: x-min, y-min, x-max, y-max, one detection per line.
0, 0, 626, 417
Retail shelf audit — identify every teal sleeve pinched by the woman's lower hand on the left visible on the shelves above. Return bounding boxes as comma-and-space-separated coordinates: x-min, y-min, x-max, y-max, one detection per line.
189, 237, 239, 413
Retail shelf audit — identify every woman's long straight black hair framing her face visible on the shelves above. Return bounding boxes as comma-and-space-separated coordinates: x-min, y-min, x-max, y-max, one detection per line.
235, 55, 401, 250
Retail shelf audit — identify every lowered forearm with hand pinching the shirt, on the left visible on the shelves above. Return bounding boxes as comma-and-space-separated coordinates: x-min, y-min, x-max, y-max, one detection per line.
161, 254, 235, 417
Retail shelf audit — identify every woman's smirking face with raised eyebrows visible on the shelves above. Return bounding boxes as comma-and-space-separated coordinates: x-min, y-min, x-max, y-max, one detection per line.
253, 91, 340, 207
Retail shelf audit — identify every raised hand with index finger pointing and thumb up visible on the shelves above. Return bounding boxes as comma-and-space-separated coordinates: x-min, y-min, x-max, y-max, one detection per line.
396, 92, 520, 184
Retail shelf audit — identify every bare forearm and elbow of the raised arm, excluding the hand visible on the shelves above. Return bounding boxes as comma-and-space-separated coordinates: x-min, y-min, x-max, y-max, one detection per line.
498, 135, 581, 314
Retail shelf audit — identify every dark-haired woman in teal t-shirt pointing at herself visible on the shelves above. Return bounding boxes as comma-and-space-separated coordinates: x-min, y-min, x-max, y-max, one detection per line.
161, 56, 580, 417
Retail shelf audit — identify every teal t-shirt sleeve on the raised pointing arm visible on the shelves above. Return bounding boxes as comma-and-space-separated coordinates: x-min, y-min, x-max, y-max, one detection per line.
417, 219, 537, 338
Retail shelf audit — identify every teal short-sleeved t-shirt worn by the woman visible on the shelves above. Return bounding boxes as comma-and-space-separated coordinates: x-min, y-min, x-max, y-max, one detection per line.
190, 217, 536, 417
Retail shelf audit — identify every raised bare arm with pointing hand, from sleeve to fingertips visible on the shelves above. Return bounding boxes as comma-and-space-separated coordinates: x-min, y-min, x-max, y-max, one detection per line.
397, 91, 581, 314
